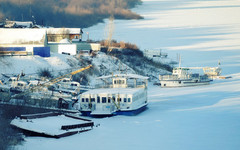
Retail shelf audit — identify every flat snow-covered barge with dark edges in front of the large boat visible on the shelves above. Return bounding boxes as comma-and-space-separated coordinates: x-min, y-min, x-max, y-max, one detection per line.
10, 112, 94, 138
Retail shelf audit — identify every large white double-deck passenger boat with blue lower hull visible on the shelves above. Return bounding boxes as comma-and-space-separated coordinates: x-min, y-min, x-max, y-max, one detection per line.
78, 74, 148, 116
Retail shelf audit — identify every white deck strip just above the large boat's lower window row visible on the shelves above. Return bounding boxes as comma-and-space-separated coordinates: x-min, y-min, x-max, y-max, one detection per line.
82, 88, 144, 95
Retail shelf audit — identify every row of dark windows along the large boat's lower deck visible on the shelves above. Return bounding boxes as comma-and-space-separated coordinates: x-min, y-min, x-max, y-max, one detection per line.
82, 97, 131, 103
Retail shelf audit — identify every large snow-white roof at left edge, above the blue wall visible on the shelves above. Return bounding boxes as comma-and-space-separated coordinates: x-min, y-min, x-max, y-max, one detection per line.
0, 28, 46, 44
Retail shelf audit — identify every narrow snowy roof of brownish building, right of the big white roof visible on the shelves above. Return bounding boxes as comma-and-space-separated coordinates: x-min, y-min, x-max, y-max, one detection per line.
46, 28, 83, 34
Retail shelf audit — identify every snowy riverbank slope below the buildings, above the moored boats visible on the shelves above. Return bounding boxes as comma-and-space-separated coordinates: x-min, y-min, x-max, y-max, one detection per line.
0, 52, 170, 84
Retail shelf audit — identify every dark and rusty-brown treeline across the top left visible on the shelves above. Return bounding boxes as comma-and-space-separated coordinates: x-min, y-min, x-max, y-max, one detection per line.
0, 0, 142, 28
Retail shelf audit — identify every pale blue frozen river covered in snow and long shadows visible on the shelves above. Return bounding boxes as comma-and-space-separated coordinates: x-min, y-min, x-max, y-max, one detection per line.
17, 0, 240, 150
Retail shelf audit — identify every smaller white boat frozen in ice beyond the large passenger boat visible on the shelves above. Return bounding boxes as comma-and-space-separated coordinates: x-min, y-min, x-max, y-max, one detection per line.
159, 67, 212, 87
